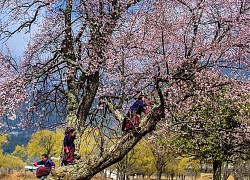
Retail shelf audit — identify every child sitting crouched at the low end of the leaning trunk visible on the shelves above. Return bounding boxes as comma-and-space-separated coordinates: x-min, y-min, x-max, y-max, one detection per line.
33, 154, 55, 179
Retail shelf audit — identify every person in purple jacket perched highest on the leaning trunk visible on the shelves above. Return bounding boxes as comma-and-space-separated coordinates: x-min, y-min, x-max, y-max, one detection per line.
122, 95, 150, 131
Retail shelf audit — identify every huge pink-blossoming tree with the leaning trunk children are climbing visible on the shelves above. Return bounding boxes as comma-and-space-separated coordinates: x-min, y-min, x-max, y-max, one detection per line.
0, 0, 250, 179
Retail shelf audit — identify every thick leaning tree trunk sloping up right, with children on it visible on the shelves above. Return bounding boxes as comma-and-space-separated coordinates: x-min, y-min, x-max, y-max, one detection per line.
48, 107, 163, 180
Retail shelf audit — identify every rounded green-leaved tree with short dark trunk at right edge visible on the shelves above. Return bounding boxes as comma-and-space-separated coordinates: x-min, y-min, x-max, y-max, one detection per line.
170, 91, 250, 179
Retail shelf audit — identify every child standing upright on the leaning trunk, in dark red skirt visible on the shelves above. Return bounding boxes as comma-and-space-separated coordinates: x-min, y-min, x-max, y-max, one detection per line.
62, 127, 76, 166
